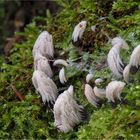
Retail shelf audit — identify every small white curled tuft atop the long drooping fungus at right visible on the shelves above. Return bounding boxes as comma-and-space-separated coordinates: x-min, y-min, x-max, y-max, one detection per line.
112, 37, 129, 50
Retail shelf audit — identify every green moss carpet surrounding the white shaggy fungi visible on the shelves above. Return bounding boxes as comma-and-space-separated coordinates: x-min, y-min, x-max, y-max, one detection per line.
0, 0, 140, 139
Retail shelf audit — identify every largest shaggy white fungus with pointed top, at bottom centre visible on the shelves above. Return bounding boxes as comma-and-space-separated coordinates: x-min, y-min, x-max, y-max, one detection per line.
54, 86, 83, 133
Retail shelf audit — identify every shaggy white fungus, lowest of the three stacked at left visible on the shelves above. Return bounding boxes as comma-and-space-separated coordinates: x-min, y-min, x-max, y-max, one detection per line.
32, 70, 58, 104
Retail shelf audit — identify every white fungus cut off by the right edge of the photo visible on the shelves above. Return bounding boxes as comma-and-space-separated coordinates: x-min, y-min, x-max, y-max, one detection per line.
129, 45, 140, 68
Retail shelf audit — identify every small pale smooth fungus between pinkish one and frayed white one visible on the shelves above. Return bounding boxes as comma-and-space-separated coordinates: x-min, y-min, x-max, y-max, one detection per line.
93, 86, 106, 99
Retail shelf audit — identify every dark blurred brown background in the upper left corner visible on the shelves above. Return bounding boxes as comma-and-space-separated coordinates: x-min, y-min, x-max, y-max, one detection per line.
0, 0, 59, 54
